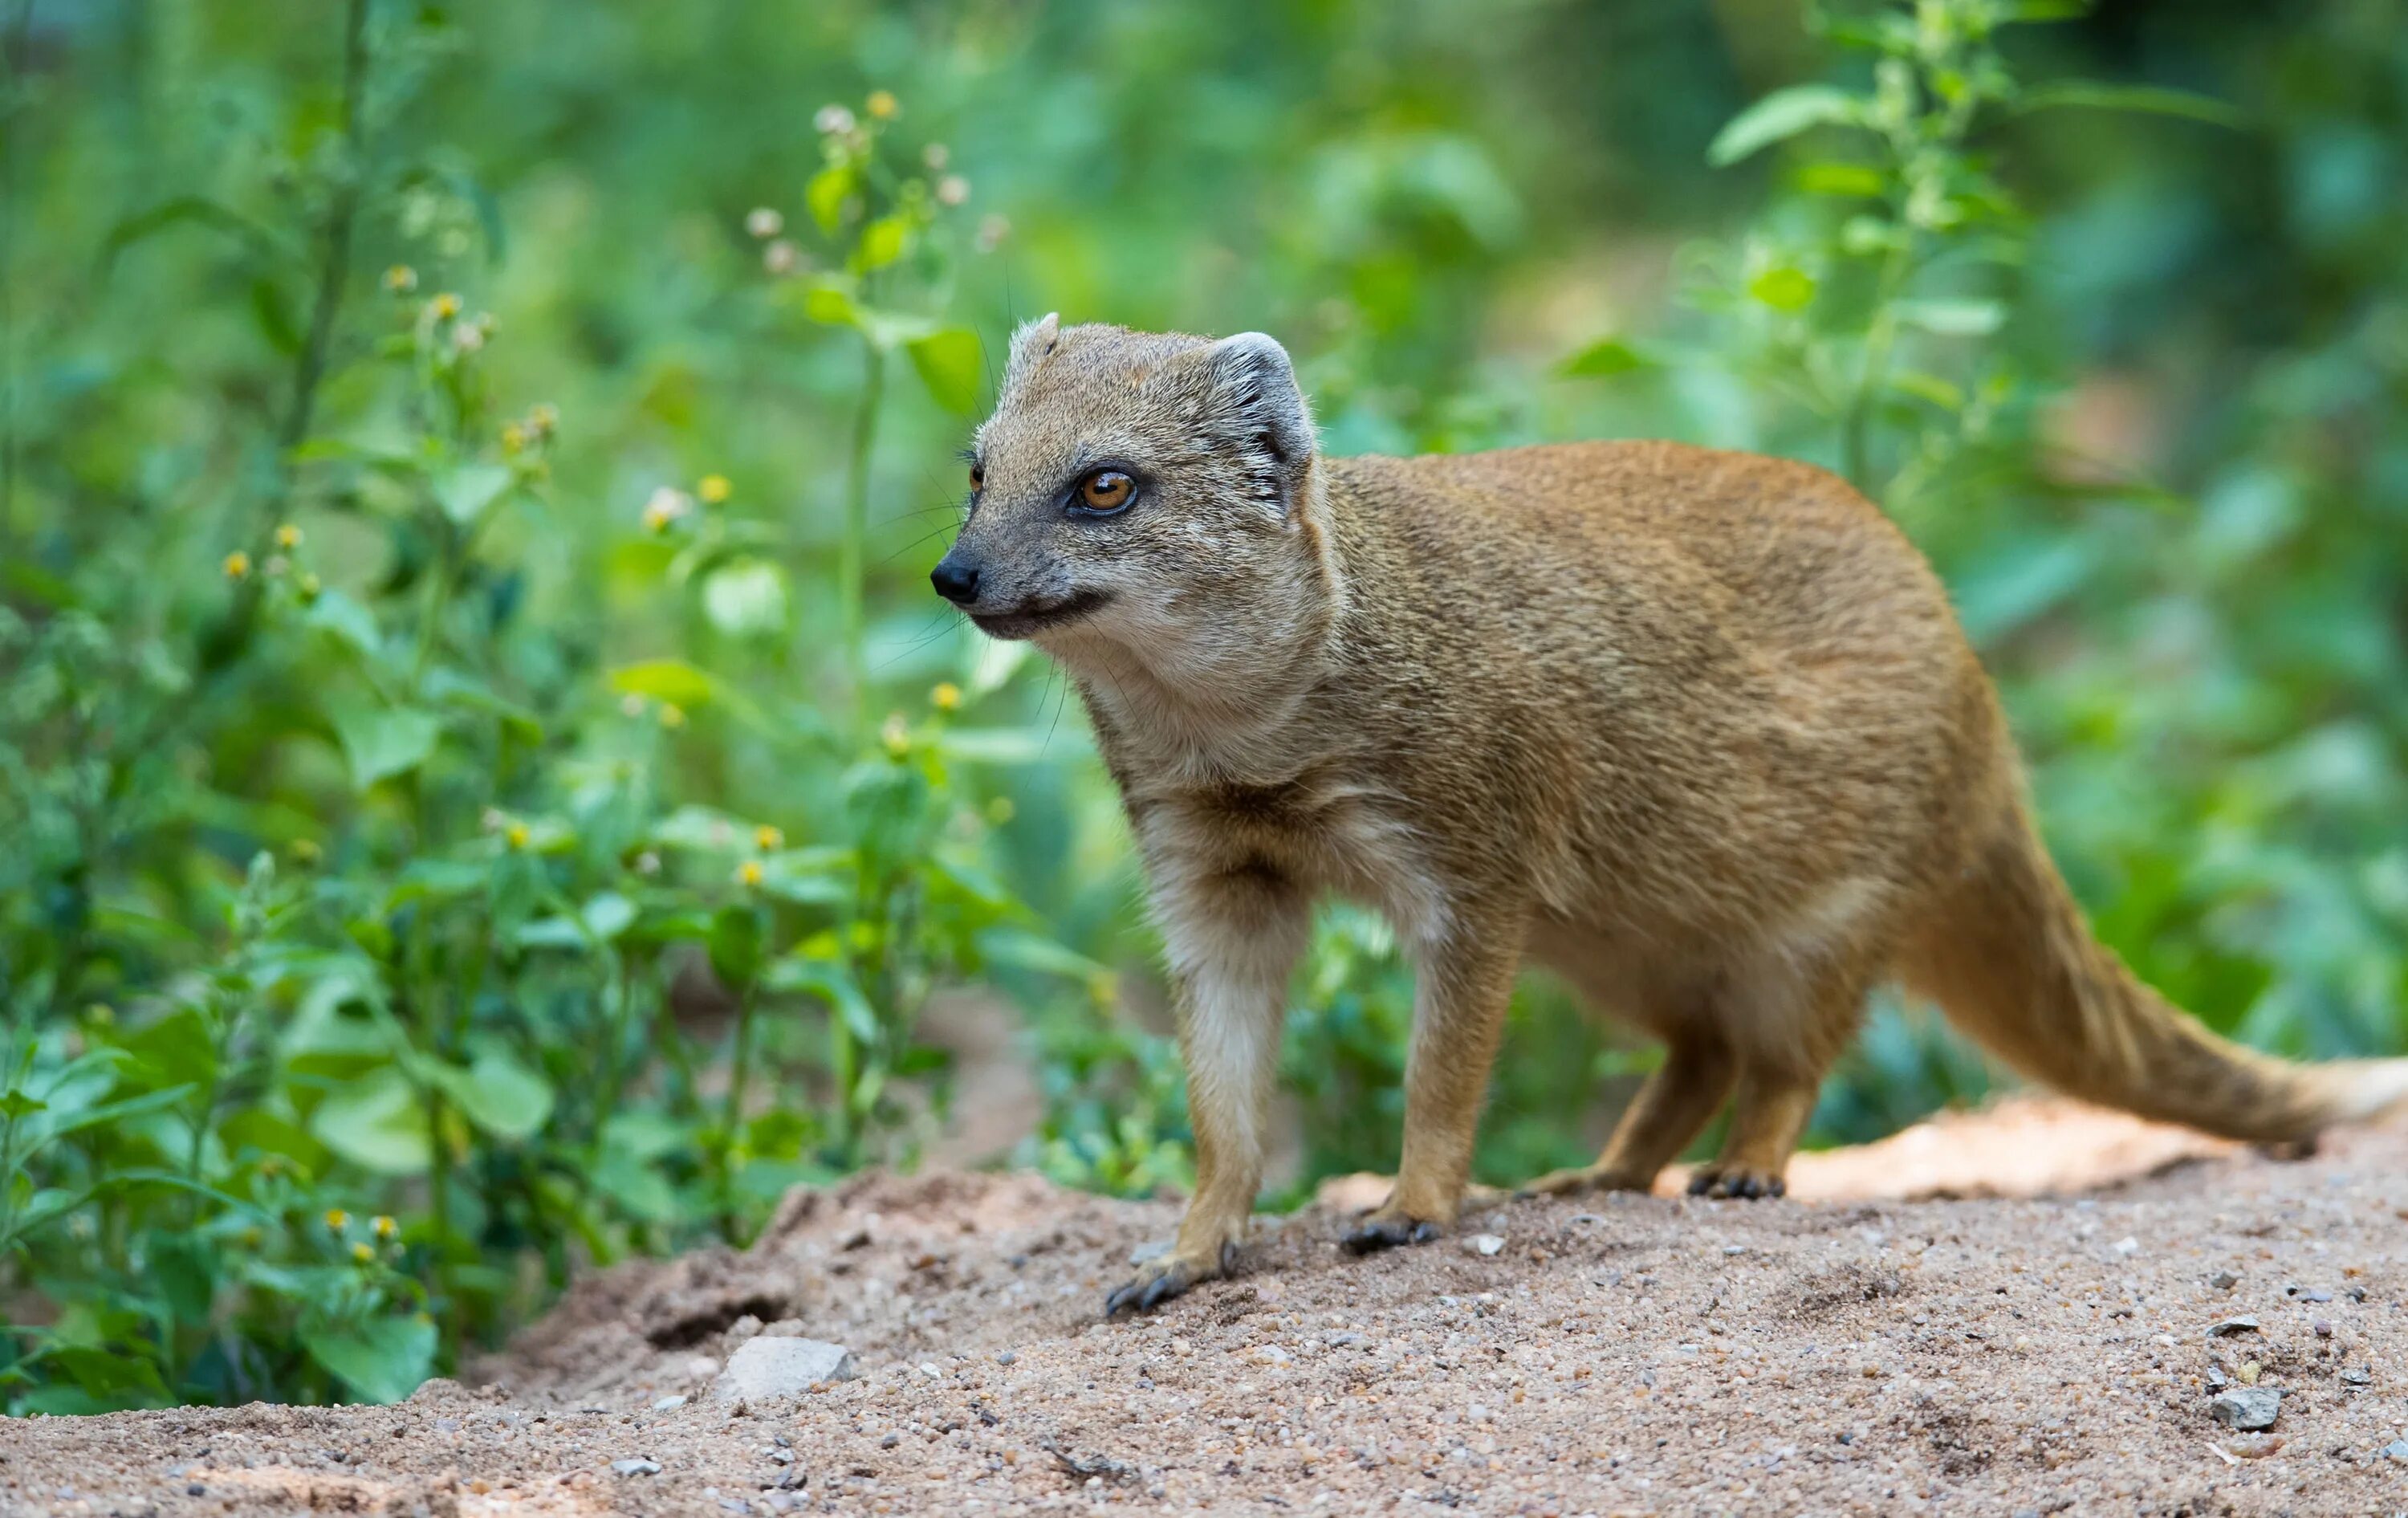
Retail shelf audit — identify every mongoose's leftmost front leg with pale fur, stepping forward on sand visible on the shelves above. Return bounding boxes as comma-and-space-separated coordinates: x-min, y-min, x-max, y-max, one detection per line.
1103, 873, 1310, 1316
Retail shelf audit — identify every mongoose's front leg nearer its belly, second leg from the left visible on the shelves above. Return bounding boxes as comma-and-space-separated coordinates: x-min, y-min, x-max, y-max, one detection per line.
1346, 926, 1522, 1253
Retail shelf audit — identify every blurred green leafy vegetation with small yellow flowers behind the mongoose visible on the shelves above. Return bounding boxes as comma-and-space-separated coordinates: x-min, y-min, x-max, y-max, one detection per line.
0, 0, 2408, 1412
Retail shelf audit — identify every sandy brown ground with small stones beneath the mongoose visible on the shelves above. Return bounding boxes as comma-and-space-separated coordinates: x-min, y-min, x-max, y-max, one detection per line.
0, 1104, 2408, 1516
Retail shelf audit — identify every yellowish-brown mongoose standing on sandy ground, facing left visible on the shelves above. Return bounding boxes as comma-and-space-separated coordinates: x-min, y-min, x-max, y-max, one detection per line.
932, 315, 2408, 1313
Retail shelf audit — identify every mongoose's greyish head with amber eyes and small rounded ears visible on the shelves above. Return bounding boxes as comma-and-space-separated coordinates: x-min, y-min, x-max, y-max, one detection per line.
929, 315, 1320, 677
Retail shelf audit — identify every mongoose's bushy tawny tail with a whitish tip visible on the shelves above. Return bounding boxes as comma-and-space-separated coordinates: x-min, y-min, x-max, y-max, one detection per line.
1898, 810, 2408, 1142
